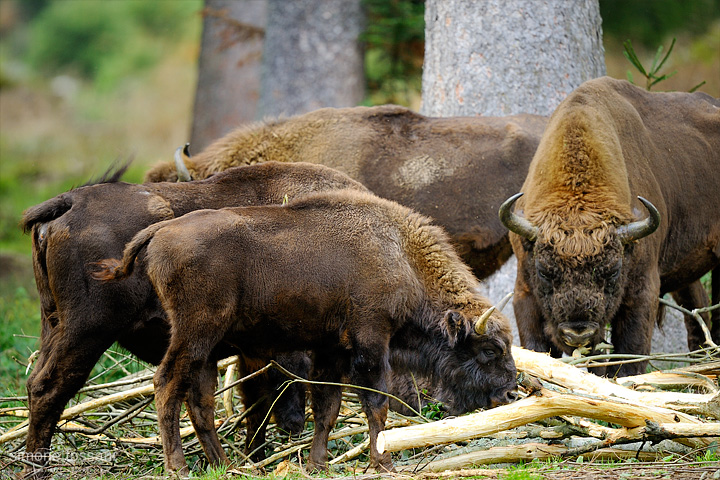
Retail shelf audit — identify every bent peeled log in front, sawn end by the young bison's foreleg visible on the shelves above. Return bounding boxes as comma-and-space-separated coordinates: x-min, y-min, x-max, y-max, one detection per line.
377, 389, 710, 453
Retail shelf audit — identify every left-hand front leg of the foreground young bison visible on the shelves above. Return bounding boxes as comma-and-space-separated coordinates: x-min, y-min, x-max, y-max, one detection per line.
308, 350, 348, 471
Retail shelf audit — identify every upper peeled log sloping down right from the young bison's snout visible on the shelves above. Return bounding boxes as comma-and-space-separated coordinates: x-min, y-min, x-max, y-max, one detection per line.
512, 346, 720, 418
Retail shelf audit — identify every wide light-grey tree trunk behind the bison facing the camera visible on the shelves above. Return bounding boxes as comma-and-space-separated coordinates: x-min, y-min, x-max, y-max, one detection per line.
422, 0, 605, 116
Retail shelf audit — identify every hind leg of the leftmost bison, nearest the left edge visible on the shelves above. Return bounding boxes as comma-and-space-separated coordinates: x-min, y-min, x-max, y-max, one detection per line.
23, 332, 112, 475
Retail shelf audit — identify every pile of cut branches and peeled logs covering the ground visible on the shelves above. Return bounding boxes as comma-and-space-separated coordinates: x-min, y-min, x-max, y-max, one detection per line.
0, 308, 720, 478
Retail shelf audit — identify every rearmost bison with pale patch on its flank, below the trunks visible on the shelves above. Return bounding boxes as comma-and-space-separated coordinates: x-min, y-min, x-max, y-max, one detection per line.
146, 105, 547, 280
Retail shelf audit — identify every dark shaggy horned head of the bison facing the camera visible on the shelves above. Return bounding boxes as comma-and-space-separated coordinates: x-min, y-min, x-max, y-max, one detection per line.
499, 194, 660, 353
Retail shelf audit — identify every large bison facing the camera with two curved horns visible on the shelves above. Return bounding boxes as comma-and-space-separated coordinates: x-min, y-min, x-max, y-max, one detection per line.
500, 77, 720, 375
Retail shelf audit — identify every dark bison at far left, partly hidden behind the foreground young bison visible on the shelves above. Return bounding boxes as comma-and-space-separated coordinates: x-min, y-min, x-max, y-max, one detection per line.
22, 162, 366, 476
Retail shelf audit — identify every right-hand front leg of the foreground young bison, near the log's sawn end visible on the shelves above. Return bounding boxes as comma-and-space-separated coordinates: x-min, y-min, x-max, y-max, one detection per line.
352, 345, 395, 472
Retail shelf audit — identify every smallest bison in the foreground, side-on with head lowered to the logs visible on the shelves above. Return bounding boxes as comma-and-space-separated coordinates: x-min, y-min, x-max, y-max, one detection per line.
96, 190, 516, 473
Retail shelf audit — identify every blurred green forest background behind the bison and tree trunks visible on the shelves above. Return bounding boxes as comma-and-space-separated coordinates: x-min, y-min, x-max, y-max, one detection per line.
0, 0, 720, 396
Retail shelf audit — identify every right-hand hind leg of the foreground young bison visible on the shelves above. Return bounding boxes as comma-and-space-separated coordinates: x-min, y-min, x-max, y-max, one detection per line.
187, 360, 230, 465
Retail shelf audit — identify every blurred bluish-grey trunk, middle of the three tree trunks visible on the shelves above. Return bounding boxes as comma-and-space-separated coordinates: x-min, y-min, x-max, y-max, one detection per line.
260, 0, 365, 116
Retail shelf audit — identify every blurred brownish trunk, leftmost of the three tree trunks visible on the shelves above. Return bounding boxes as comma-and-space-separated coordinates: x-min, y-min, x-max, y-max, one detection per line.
190, 0, 267, 152
